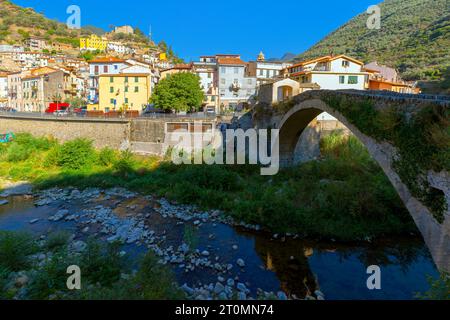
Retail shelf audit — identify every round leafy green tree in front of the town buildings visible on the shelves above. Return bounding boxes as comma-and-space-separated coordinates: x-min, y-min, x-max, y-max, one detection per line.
150, 73, 204, 112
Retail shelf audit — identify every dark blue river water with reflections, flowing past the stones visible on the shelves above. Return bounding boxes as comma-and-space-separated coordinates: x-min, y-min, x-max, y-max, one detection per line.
0, 192, 438, 300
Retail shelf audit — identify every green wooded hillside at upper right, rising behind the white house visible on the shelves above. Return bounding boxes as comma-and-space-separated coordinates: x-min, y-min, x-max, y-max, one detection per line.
295, 0, 450, 80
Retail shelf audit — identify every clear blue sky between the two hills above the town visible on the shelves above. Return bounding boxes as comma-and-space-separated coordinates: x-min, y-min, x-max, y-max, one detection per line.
13, 0, 380, 61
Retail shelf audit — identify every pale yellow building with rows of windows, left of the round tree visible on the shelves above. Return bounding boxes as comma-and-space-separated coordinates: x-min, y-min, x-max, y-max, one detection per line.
98, 73, 152, 112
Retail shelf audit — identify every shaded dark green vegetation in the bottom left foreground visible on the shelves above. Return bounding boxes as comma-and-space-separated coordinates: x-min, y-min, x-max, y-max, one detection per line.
0, 232, 185, 300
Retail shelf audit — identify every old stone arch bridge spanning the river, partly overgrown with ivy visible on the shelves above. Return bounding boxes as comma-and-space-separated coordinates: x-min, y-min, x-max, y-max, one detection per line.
252, 90, 450, 271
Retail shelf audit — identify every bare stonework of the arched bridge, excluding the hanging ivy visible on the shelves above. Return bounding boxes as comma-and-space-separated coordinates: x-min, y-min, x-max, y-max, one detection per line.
253, 90, 450, 272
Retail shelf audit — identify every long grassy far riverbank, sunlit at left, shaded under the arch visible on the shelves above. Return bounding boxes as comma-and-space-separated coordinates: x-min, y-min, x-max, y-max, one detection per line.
0, 134, 417, 241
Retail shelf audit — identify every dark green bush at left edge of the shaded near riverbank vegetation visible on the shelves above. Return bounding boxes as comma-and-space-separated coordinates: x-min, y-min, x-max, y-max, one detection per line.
0, 231, 36, 271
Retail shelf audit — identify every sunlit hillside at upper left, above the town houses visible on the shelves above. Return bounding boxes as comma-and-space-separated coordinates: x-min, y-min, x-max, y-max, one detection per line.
0, 0, 154, 53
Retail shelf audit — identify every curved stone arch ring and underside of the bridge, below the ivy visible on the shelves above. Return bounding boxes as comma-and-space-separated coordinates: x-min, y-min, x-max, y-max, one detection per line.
273, 98, 450, 272
